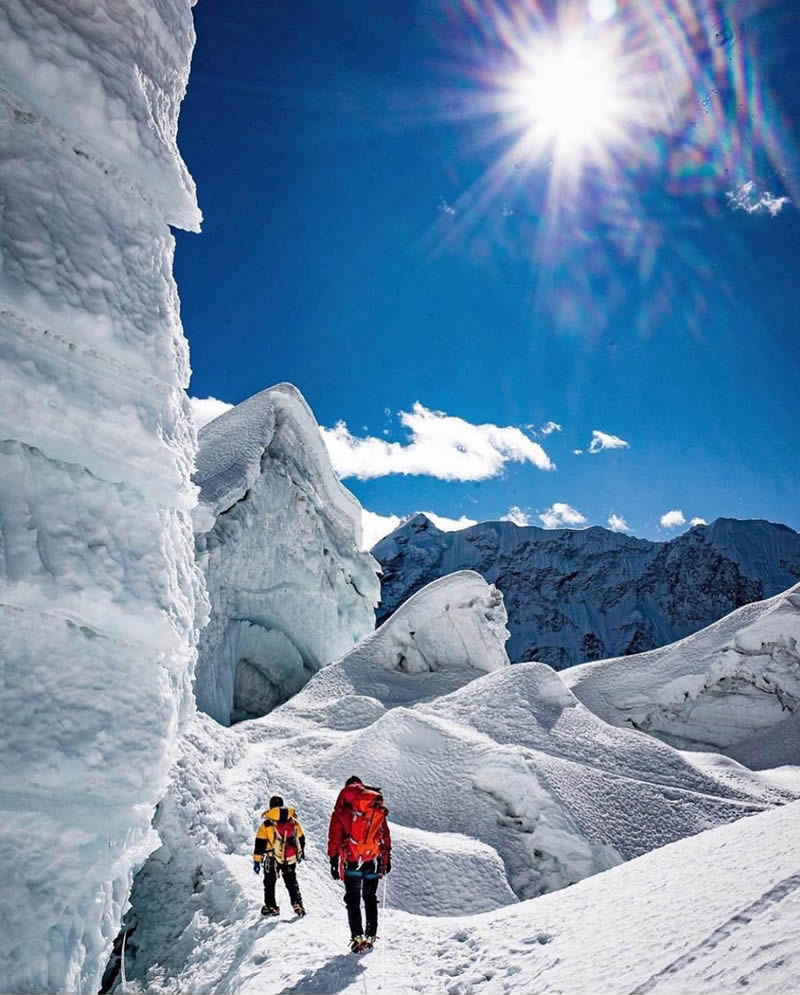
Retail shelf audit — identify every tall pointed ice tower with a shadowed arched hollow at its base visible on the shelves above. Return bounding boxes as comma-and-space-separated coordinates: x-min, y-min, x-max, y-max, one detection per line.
194, 384, 379, 724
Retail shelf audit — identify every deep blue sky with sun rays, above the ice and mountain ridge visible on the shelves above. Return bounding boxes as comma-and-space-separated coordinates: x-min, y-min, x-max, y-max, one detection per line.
175, 0, 800, 538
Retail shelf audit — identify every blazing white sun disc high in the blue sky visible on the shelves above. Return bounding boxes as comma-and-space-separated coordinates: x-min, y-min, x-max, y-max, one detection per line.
506, 34, 629, 167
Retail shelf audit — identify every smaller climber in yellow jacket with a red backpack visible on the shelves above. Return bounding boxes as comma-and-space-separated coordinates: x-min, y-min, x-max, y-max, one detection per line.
253, 795, 306, 916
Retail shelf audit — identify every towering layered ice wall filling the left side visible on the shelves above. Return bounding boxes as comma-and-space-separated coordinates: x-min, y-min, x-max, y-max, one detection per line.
0, 0, 204, 991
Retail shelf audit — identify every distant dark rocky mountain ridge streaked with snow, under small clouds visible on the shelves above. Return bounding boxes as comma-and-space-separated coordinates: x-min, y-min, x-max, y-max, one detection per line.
372, 515, 800, 670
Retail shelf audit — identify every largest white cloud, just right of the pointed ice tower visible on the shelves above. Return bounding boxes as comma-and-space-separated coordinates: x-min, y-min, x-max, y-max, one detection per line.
320, 402, 555, 480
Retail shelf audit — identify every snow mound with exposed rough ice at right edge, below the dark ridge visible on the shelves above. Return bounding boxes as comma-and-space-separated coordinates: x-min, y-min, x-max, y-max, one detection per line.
563, 585, 800, 767
